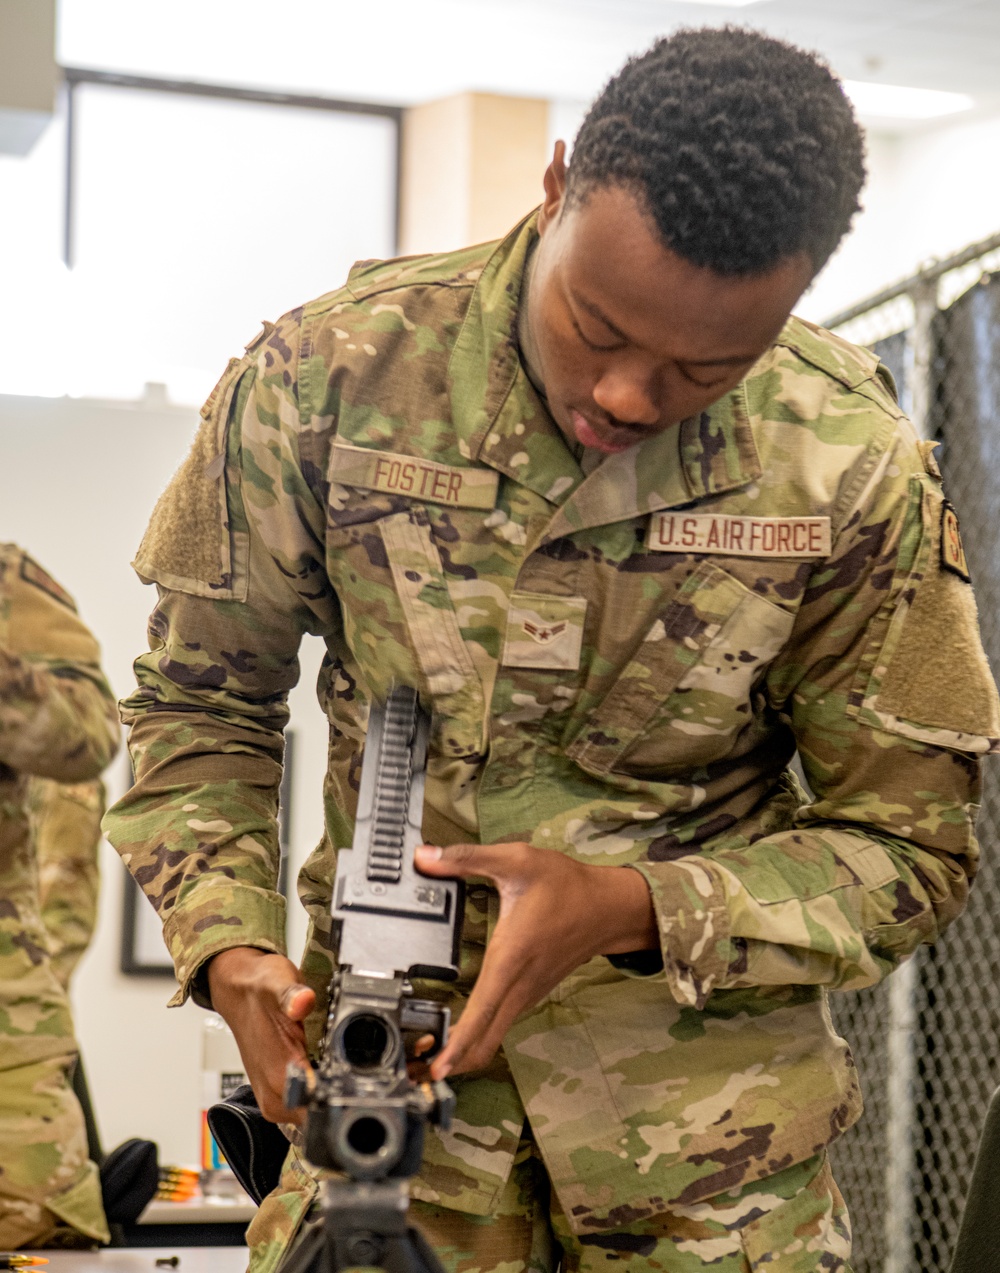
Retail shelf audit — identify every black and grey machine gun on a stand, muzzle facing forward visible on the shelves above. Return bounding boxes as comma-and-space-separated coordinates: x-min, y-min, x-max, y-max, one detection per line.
281, 686, 462, 1273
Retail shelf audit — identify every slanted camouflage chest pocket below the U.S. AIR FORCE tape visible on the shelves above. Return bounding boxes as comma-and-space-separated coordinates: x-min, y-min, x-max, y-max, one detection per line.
567, 561, 794, 777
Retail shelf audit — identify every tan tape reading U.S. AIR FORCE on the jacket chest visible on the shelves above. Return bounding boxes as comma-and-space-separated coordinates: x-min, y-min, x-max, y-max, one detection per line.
646, 513, 831, 558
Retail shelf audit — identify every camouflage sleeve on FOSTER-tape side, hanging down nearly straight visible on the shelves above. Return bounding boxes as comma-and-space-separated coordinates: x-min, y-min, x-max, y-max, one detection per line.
104, 320, 336, 1003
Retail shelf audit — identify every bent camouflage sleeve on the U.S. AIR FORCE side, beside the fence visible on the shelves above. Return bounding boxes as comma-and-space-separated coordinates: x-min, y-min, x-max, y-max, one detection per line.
637, 423, 1000, 1006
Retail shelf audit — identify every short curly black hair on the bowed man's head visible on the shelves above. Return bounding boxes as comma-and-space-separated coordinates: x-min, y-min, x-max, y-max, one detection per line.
566, 27, 865, 275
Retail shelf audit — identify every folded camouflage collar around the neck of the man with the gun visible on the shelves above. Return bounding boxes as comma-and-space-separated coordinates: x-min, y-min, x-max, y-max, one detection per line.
449, 210, 761, 524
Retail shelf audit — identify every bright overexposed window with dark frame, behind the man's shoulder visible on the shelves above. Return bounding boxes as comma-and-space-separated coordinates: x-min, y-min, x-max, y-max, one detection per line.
0, 84, 396, 402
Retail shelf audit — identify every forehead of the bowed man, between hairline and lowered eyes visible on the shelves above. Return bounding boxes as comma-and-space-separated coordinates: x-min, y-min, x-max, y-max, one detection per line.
552, 186, 812, 360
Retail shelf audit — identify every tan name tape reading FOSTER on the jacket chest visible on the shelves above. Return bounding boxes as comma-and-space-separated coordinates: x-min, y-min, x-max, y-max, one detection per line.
330, 442, 500, 508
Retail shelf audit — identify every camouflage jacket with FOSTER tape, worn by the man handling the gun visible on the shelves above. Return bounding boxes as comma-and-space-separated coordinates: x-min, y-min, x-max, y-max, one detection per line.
106, 218, 1000, 1232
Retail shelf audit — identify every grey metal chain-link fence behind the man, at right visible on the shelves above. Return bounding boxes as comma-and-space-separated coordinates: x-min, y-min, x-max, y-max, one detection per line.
827, 234, 1000, 1273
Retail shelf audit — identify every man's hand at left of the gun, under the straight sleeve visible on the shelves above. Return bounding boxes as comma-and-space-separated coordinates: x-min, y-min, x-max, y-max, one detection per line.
202, 946, 316, 1124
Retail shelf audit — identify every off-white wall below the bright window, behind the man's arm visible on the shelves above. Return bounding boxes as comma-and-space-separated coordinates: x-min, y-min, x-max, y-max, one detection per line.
0, 396, 326, 1164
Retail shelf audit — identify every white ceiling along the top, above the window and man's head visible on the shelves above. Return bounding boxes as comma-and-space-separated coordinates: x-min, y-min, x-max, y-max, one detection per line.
60, 0, 1000, 113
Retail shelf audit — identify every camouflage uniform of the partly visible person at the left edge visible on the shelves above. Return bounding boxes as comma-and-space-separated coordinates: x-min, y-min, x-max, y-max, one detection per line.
0, 544, 118, 1248
